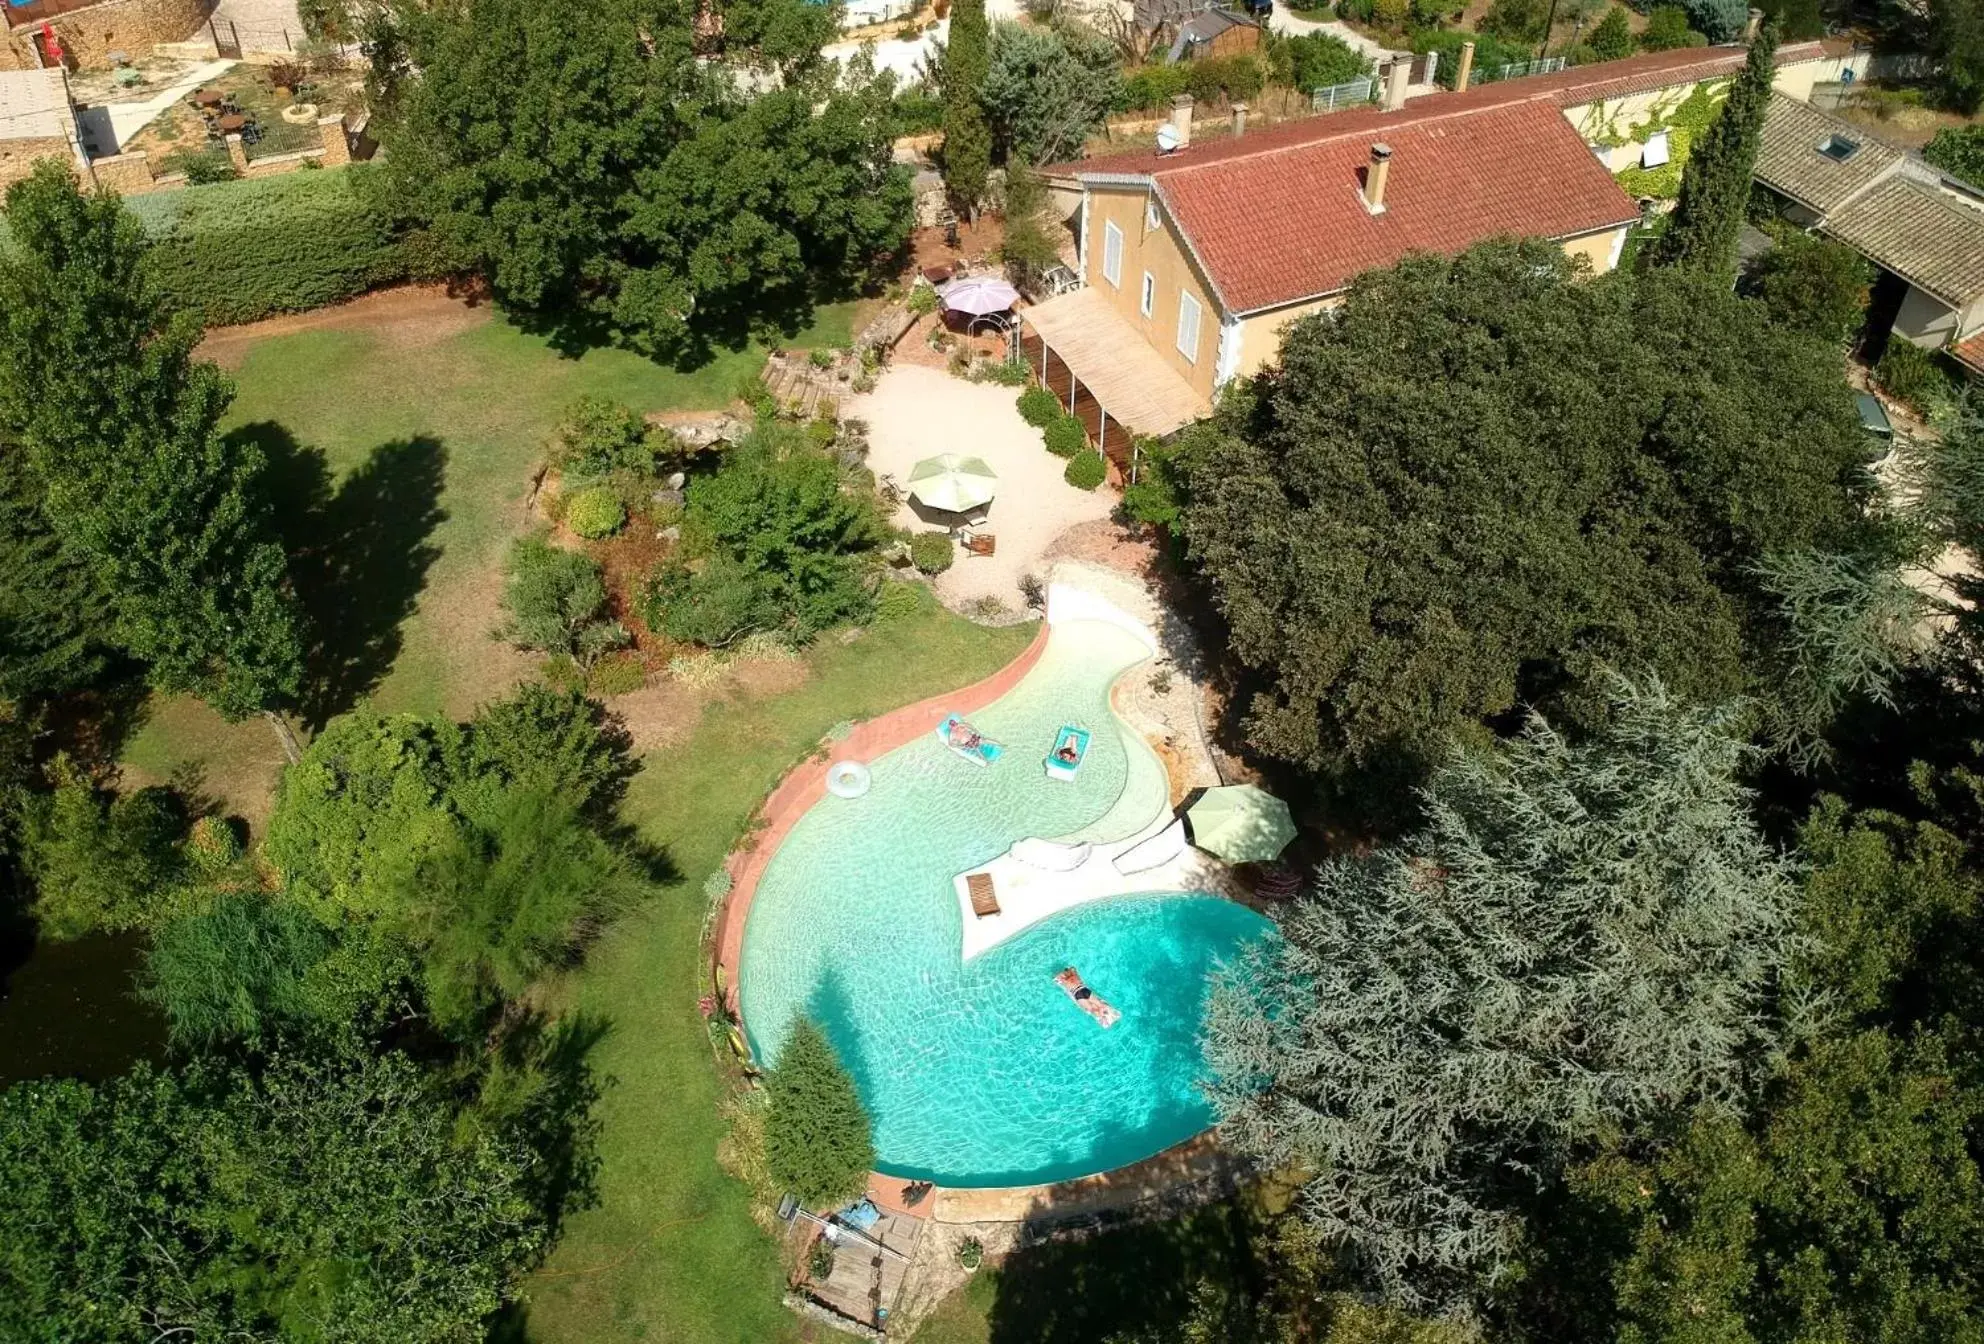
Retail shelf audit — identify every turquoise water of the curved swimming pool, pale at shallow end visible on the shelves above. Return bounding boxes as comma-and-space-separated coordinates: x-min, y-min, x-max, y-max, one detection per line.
738, 621, 1270, 1185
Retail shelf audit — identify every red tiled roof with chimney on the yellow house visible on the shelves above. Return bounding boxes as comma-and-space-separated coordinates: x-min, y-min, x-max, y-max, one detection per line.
1047, 99, 1639, 314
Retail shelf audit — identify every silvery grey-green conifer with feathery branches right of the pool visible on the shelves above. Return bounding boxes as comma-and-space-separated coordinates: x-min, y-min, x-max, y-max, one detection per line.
1206, 683, 1794, 1304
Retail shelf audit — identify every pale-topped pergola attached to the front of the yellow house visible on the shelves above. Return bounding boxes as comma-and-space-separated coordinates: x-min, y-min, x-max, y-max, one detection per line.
1020, 290, 1212, 478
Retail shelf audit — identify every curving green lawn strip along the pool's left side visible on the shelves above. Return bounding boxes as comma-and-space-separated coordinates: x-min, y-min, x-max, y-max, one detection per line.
528, 604, 1032, 1344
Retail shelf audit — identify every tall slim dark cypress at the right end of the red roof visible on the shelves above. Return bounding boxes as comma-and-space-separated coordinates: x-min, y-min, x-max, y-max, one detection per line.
1647, 26, 1778, 276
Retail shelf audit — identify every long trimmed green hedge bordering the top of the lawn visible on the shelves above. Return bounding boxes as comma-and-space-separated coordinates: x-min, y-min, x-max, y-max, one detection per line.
125, 165, 450, 326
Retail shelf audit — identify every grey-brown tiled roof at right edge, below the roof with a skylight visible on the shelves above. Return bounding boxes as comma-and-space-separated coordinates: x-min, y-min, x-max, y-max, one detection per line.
1819, 173, 1984, 308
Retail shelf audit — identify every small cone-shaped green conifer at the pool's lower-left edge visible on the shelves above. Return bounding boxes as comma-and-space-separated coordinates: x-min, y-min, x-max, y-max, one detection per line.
764, 1018, 875, 1209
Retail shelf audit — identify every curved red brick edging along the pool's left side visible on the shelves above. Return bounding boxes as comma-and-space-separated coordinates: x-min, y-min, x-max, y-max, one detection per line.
716, 621, 1048, 1040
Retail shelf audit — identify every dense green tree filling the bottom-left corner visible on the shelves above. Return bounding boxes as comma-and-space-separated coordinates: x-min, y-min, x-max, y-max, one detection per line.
0, 1054, 548, 1344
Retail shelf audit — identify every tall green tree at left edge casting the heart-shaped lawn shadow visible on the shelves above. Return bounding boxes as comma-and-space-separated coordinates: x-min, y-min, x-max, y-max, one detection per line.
0, 163, 304, 748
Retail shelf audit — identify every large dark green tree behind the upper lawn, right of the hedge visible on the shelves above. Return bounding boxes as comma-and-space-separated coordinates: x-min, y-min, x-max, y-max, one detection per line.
375, 0, 911, 359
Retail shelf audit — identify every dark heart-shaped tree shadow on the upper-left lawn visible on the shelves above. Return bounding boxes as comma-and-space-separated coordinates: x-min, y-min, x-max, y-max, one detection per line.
234, 421, 448, 731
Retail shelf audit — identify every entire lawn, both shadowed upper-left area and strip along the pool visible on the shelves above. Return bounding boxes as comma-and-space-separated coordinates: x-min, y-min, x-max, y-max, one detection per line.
125, 300, 1032, 1344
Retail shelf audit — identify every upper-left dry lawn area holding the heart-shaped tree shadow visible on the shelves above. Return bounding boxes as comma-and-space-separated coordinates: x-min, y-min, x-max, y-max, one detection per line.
125, 310, 781, 822
